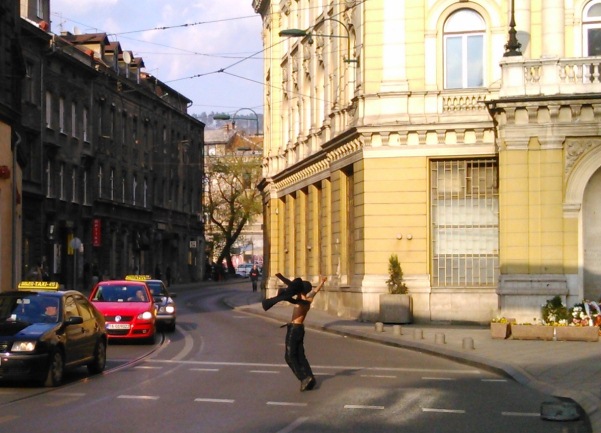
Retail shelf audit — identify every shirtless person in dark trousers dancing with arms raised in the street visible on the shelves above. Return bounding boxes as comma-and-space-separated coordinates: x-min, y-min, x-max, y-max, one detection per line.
263, 274, 327, 392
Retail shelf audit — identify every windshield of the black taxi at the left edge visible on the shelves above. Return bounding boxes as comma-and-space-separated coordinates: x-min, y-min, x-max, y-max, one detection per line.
0, 293, 59, 323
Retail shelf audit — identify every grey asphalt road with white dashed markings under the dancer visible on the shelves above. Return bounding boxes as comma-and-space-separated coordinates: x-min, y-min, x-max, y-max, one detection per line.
0, 287, 585, 433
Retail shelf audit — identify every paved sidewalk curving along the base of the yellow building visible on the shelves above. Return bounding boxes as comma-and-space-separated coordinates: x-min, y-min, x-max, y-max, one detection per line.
216, 290, 601, 433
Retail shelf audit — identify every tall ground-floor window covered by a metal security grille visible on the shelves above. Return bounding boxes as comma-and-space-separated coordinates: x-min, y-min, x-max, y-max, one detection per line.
430, 159, 499, 288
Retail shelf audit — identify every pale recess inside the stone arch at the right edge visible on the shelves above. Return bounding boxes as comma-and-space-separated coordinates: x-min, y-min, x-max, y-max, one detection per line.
581, 168, 601, 301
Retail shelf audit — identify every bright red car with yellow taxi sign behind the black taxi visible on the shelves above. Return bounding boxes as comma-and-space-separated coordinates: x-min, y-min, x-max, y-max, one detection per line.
90, 280, 156, 344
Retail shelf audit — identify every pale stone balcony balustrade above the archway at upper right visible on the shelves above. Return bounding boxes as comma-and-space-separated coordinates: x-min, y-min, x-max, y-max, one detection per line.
499, 57, 601, 98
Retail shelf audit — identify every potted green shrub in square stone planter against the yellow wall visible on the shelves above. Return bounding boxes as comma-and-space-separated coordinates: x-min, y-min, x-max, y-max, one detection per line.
379, 254, 413, 323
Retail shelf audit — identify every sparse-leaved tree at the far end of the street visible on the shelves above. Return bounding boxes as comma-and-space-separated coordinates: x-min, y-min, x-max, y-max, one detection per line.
204, 150, 263, 273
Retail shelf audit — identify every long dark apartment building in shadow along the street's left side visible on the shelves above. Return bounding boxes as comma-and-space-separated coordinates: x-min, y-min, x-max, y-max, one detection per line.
20, 0, 204, 290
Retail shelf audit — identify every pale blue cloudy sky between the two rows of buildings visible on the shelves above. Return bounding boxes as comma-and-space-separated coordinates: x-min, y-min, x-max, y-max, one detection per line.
50, 0, 263, 116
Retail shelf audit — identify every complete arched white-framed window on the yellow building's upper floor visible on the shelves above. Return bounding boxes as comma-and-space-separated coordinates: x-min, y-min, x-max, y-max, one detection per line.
444, 9, 486, 89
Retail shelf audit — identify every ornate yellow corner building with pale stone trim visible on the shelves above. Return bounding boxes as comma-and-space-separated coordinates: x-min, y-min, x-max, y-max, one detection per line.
253, 0, 601, 322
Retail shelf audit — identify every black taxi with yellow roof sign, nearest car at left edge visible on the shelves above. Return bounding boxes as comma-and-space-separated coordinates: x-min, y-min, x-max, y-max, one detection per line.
0, 281, 107, 386
